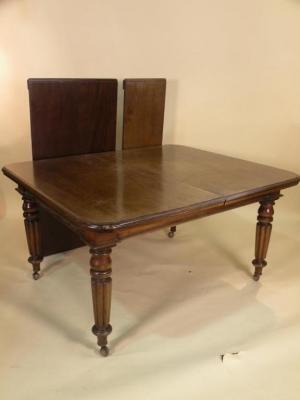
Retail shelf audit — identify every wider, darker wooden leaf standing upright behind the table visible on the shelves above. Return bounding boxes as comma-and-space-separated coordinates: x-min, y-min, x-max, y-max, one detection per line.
28, 79, 118, 256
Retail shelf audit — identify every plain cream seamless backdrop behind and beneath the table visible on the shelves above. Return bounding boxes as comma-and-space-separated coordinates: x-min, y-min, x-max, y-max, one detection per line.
0, 0, 300, 400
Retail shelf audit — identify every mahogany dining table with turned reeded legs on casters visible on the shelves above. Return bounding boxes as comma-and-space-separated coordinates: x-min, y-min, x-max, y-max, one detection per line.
3, 145, 300, 356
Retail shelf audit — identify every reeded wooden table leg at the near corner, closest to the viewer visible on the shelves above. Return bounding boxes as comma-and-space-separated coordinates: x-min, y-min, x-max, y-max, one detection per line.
90, 248, 112, 357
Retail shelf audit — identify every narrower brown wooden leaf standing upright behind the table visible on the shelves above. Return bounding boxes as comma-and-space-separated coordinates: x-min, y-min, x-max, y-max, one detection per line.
123, 79, 166, 149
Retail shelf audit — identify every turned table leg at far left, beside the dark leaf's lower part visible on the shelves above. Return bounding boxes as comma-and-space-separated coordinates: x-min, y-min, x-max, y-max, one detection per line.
22, 191, 43, 280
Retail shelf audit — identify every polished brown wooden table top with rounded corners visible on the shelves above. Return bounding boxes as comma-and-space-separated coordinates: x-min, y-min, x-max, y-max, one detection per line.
3, 145, 300, 229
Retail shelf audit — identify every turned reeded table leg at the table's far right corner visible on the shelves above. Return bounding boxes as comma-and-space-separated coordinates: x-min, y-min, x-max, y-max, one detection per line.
252, 195, 279, 281
